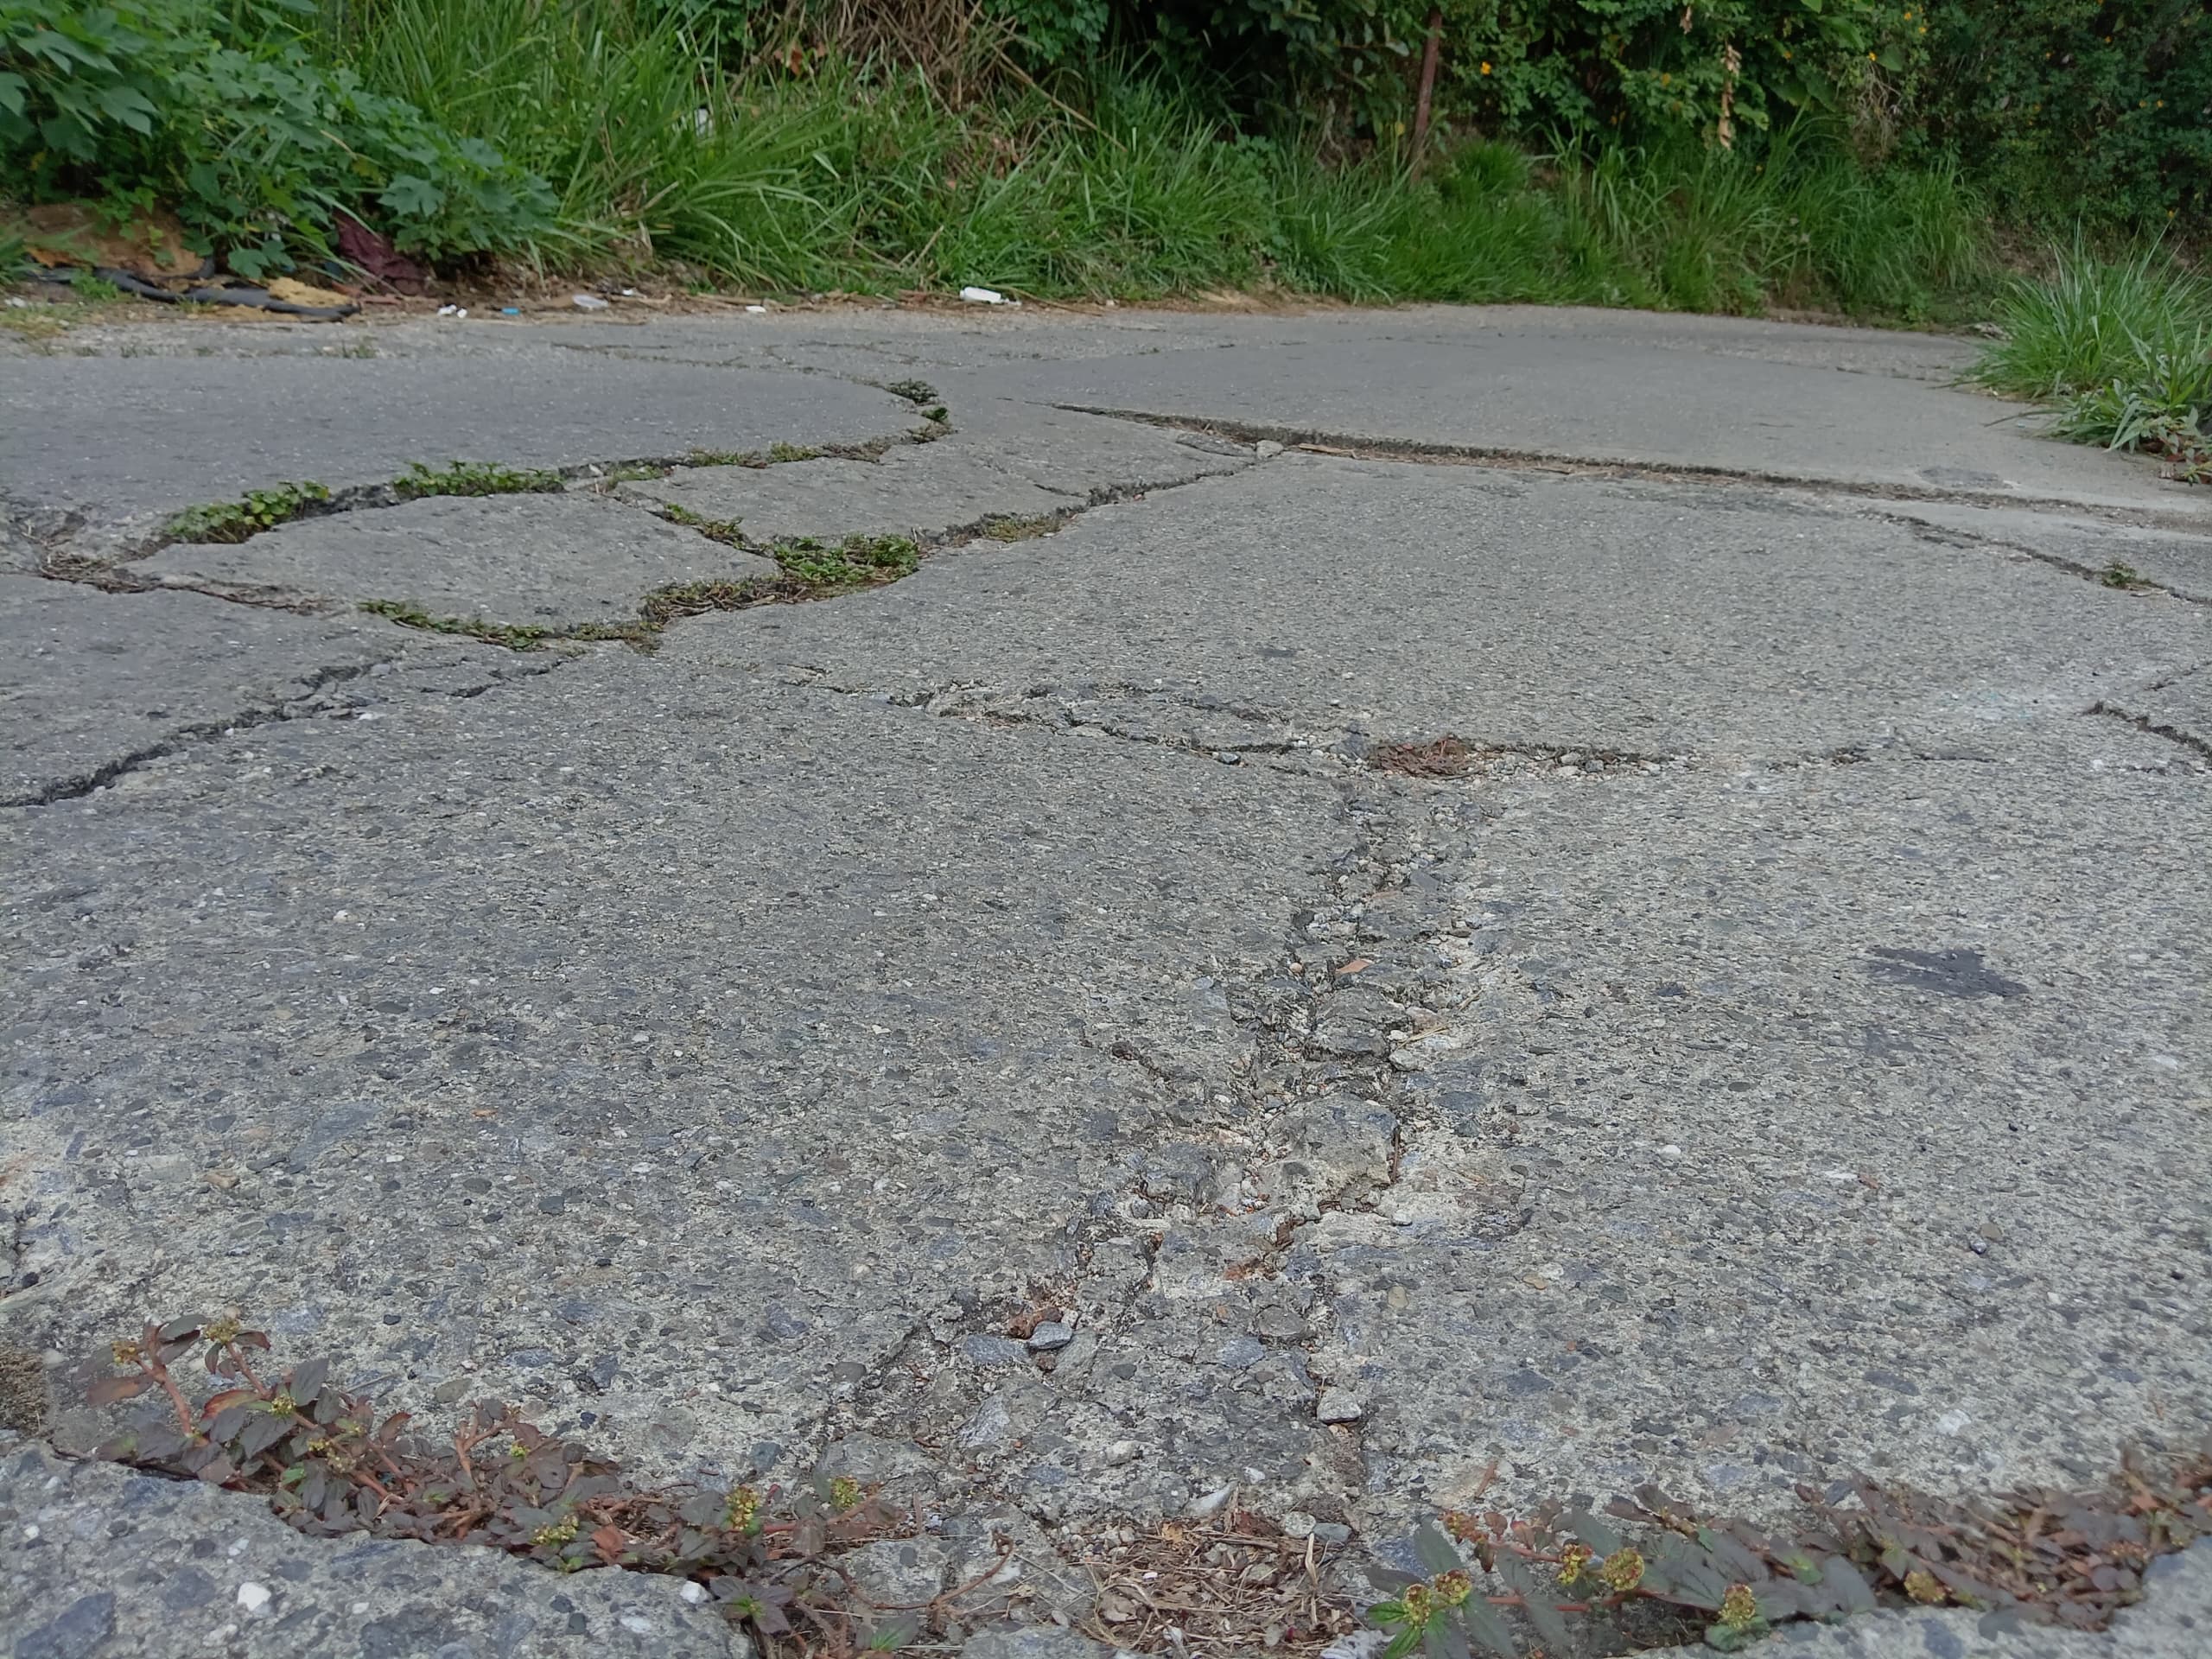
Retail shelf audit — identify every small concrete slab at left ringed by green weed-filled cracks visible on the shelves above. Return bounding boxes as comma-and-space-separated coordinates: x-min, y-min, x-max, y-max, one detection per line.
133, 491, 779, 628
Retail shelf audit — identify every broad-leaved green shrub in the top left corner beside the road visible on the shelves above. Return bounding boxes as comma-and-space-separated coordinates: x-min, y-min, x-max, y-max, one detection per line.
0, 0, 553, 274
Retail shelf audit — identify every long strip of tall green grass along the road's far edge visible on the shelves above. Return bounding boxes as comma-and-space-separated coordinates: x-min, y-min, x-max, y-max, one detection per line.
327, 0, 1982, 322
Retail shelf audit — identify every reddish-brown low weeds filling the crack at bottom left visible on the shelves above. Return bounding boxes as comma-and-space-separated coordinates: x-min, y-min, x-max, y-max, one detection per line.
91, 1319, 920, 1655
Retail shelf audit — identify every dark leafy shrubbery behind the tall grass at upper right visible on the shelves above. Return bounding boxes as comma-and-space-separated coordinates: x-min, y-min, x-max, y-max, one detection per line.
1000, 0, 2212, 230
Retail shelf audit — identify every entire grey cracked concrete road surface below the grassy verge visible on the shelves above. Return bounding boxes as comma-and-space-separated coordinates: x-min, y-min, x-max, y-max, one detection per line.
0, 309, 2212, 1659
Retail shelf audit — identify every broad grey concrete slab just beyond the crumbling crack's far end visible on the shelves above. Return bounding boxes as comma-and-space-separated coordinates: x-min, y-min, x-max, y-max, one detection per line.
668, 455, 2212, 763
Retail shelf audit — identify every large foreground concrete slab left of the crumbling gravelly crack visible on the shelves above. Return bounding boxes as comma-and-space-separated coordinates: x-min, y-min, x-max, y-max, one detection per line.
7, 652, 1334, 1476
